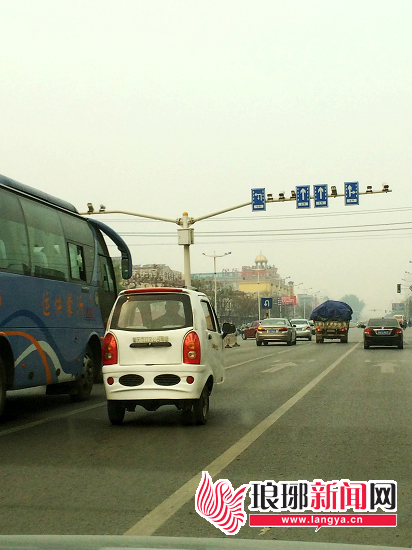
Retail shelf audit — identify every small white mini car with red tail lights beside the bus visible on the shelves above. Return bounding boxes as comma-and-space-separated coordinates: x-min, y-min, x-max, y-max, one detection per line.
102, 288, 235, 424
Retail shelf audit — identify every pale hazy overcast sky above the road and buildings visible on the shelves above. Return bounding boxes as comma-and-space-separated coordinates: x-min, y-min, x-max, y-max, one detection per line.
0, 0, 412, 315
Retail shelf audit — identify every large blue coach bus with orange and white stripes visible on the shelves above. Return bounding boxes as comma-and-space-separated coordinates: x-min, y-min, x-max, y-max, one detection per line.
0, 175, 132, 415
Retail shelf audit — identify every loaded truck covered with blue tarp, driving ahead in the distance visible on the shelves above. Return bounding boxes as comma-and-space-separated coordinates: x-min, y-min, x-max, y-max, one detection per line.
310, 300, 353, 344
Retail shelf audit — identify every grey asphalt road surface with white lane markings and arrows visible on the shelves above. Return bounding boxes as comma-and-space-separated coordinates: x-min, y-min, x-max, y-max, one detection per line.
0, 329, 412, 547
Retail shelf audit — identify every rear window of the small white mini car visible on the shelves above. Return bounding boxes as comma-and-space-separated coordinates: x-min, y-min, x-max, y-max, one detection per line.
110, 293, 193, 332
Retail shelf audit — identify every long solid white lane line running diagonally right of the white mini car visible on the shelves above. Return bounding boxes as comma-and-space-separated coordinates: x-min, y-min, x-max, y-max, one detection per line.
124, 342, 359, 536
